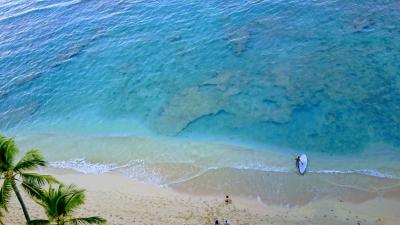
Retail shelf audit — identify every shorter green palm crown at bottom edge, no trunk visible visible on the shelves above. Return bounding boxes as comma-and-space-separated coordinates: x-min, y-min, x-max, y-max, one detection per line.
28, 184, 106, 225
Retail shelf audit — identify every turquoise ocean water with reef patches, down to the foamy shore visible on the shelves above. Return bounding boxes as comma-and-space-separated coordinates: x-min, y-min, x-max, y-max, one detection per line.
0, 0, 400, 191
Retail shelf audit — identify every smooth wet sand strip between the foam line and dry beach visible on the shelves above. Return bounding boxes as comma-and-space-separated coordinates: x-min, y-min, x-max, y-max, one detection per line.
170, 168, 400, 207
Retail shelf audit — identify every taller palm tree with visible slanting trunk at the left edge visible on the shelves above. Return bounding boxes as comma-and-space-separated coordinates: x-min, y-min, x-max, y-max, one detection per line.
0, 135, 57, 224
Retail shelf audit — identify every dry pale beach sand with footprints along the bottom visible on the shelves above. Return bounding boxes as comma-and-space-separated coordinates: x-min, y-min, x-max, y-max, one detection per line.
4, 169, 400, 225
